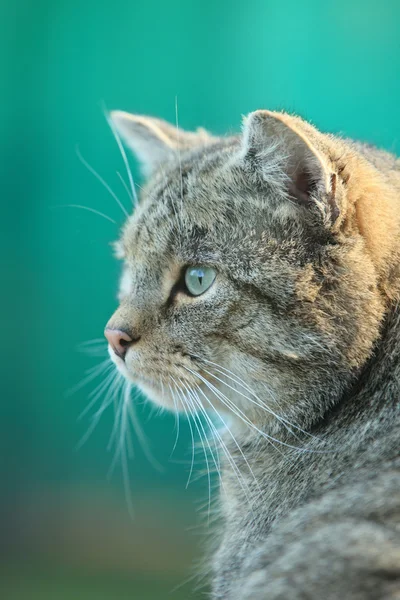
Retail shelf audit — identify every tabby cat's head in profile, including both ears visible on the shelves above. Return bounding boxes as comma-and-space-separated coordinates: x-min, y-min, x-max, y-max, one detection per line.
106, 111, 384, 423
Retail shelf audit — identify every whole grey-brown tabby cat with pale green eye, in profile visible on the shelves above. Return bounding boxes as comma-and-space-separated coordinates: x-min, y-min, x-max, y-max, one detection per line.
105, 110, 400, 600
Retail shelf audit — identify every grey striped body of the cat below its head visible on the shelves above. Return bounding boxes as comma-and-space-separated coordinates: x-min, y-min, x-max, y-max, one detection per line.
213, 304, 400, 600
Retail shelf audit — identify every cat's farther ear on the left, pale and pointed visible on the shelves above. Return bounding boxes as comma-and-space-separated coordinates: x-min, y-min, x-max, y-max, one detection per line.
110, 110, 211, 176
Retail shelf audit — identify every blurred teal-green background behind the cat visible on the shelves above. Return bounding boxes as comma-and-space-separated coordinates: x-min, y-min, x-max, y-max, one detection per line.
0, 0, 400, 600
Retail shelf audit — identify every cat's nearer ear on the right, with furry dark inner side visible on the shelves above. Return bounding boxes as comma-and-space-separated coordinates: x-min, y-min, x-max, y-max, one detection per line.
243, 110, 339, 224
